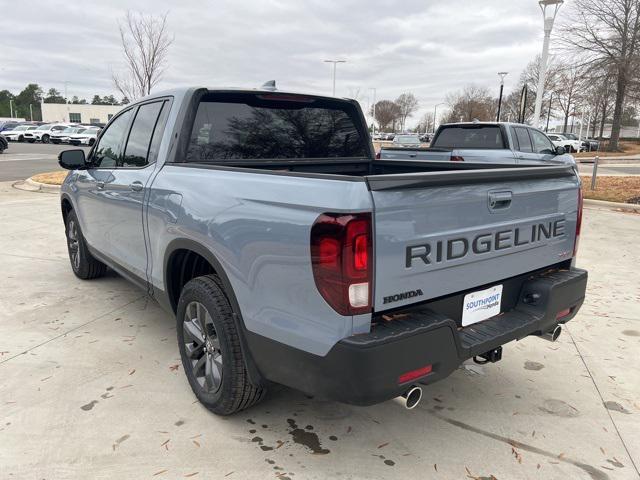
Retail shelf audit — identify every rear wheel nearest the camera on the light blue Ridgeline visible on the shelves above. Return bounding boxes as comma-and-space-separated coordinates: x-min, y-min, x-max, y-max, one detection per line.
176, 275, 265, 415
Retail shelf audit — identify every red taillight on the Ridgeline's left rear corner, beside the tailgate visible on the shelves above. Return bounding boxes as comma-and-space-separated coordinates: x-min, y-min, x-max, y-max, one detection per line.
311, 213, 373, 315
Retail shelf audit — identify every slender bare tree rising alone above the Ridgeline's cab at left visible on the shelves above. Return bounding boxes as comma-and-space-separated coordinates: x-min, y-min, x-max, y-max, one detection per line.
112, 11, 174, 100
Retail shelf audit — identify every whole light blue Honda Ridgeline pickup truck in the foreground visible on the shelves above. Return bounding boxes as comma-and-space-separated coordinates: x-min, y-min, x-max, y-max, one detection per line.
59, 88, 587, 415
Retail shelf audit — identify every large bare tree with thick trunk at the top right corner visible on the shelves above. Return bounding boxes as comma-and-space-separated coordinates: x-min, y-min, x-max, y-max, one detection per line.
560, 0, 640, 150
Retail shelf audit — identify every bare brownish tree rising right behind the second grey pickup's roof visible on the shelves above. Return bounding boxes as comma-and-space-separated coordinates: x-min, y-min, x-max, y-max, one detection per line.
444, 85, 498, 122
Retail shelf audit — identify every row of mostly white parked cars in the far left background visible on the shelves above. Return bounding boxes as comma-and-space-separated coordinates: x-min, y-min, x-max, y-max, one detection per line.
1, 123, 102, 146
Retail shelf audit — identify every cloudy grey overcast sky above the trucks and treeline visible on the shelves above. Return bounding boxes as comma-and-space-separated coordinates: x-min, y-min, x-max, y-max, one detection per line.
0, 0, 566, 123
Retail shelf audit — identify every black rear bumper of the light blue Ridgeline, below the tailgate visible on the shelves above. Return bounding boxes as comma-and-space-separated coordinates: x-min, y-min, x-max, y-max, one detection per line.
246, 268, 587, 405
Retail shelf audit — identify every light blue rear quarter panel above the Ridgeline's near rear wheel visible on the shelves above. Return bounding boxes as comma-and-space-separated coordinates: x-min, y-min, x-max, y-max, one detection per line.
148, 164, 372, 355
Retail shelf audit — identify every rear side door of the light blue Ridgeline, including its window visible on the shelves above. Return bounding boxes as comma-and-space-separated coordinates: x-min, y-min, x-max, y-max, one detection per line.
98, 99, 169, 283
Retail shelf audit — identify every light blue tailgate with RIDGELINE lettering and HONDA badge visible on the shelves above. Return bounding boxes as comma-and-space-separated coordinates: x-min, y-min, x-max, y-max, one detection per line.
367, 166, 579, 311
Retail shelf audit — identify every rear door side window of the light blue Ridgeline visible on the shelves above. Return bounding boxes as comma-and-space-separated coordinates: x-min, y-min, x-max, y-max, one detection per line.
118, 101, 165, 168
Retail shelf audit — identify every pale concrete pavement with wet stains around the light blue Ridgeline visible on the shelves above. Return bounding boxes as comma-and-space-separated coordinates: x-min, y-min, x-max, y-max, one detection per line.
0, 182, 640, 480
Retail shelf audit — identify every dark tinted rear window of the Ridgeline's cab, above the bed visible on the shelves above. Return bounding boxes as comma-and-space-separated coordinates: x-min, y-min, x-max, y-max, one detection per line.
187, 94, 368, 162
